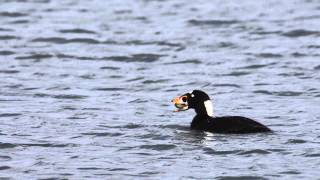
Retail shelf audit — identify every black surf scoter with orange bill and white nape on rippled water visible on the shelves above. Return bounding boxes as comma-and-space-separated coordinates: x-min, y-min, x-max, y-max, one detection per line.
172, 90, 271, 134
